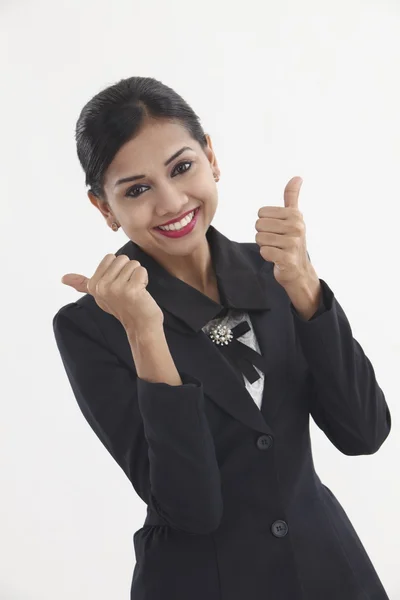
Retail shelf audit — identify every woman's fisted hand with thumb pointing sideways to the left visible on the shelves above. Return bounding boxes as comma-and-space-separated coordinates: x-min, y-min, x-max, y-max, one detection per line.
61, 254, 164, 331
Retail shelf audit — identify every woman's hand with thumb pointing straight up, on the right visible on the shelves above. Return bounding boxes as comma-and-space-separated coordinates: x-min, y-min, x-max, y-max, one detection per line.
256, 177, 313, 287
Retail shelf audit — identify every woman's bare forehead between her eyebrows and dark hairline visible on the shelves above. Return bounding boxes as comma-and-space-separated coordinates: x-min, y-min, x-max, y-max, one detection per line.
105, 120, 198, 184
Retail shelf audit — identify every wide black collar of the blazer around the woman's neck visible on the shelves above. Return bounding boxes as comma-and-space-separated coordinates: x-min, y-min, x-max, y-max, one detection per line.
115, 225, 273, 333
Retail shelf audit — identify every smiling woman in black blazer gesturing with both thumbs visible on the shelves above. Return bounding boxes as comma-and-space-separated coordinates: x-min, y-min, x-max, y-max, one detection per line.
53, 77, 391, 600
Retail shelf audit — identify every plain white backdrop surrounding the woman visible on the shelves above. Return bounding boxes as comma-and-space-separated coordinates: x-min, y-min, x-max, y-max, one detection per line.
0, 0, 400, 600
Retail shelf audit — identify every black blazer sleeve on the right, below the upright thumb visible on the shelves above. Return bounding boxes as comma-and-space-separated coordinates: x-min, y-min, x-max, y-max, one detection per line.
291, 279, 391, 456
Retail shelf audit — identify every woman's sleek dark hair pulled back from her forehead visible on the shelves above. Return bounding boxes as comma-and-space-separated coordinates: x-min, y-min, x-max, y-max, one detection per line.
75, 77, 207, 201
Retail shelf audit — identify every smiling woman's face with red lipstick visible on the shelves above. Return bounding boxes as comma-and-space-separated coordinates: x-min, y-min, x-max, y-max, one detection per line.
88, 120, 219, 272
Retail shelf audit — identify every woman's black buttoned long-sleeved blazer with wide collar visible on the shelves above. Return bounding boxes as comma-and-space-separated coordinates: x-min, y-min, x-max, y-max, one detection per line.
53, 226, 391, 600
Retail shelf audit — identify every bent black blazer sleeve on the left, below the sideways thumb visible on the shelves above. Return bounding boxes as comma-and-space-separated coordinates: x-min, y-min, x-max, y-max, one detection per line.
53, 303, 222, 534
